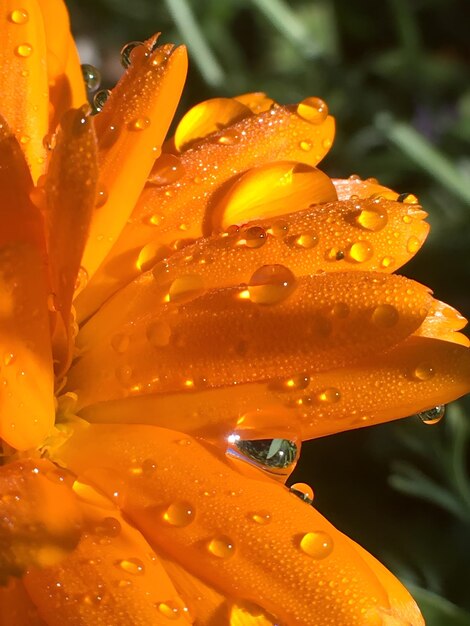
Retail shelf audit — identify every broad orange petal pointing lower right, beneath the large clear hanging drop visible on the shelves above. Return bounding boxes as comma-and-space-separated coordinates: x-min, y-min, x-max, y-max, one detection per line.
55, 425, 418, 626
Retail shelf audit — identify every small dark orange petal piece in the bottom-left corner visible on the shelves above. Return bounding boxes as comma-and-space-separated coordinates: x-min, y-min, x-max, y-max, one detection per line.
0, 578, 47, 626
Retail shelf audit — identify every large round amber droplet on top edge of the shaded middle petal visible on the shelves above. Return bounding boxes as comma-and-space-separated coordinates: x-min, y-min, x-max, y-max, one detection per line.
248, 265, 296, 304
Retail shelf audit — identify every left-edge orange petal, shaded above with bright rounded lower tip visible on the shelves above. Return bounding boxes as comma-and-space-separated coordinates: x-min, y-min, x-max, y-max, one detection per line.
0, 118, 54, 449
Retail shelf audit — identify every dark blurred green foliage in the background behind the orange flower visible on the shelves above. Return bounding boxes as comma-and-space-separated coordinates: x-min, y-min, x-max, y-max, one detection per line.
68, 0, 470, 626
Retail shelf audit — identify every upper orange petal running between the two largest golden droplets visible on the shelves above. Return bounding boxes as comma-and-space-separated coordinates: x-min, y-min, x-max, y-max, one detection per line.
76, 105, 334, 320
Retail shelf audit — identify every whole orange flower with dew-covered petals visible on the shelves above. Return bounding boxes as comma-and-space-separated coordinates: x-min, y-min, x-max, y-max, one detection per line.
0, 0, 470, 626
